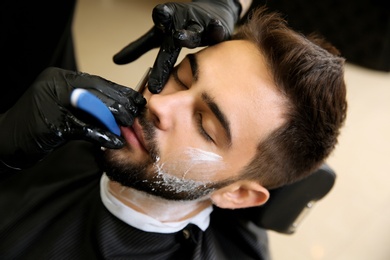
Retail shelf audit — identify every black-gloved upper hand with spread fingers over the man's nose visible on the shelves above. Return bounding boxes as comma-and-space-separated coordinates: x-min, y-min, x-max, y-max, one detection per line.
114, 0, 241, 93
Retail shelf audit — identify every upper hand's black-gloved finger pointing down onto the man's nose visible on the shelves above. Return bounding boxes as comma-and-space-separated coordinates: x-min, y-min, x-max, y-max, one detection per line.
148, 36, 181, 94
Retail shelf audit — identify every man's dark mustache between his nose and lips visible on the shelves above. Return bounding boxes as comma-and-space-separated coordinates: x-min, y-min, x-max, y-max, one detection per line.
138, 108, 160, 162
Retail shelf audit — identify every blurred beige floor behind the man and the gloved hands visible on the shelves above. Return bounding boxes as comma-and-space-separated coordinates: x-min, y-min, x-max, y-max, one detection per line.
74, 0, 390, 260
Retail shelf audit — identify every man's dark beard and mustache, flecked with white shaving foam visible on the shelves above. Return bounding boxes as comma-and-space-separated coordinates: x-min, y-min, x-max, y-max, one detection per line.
103, 110, 235, 201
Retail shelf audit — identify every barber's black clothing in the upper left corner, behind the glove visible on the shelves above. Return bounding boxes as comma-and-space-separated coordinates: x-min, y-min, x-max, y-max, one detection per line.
0, 0, 76, 113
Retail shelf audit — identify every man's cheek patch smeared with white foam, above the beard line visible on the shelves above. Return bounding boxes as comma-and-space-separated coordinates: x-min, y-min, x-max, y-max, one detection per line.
156, 147, 229, 182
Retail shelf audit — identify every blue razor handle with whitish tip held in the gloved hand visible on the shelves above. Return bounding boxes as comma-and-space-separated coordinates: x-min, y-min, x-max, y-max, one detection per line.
70, 88, 121, 135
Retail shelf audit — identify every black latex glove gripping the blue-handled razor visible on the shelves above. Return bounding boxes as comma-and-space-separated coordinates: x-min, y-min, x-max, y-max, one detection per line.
0, 68, 146, 168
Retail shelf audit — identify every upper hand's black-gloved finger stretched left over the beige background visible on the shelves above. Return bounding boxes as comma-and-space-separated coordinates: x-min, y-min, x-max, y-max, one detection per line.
113, 27, 163, 65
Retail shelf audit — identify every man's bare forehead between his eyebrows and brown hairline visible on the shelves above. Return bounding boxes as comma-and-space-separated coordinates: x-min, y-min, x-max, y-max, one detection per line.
197, 40, 285, 158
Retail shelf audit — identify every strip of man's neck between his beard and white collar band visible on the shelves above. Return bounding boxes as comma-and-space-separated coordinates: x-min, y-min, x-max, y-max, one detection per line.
108, 181, 211, 222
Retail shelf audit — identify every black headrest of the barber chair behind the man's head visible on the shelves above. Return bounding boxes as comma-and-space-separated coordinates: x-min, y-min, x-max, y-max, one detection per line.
241, 164, 336, 234
